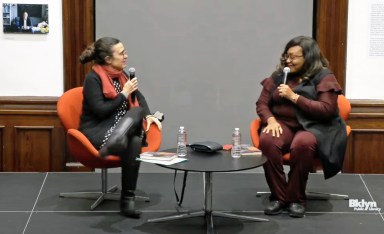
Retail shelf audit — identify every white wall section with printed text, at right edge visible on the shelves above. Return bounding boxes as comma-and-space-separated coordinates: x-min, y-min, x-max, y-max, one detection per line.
346, 0, 384, 100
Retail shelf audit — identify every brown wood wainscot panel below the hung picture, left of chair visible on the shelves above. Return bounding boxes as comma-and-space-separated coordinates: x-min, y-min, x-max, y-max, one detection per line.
0, 97, 67, 172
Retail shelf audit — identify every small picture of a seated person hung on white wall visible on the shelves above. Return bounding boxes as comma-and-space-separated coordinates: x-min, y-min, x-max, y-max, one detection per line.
3, 3, 49, 34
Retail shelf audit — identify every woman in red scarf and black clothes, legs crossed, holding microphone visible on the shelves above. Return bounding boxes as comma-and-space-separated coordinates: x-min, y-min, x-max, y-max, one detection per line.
79, 37, 161, 218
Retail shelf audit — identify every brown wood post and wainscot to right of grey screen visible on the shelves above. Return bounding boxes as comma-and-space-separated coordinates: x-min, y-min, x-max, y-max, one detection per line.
315, 0, 384, 173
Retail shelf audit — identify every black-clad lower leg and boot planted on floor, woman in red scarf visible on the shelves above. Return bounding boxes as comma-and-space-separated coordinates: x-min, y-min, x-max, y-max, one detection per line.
120, 136, 142, 219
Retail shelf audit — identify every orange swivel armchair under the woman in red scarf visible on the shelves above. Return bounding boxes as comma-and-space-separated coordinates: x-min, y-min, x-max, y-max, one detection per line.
57, 87, 162, 210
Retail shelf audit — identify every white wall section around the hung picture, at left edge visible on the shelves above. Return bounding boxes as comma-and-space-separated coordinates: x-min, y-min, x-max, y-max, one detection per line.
0, 0, 64, 96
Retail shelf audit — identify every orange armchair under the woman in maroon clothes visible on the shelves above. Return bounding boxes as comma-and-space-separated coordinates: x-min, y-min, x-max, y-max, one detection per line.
250, 95, 351, 199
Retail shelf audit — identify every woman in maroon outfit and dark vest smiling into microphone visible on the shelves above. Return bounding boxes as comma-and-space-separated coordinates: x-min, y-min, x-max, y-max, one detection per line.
256, 36, 347, 217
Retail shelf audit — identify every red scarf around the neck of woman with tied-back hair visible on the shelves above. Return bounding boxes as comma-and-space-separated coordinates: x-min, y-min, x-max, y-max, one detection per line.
92, 64, 139, 107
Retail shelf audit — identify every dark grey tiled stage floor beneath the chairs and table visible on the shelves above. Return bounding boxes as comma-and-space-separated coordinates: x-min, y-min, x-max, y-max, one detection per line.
0, 172, 384, 234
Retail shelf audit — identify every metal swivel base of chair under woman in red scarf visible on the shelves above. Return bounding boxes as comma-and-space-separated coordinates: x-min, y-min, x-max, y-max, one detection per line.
60, 168, 150, 210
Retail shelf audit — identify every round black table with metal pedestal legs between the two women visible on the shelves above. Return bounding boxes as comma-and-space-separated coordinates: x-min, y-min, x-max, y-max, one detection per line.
148, 148, 268, 233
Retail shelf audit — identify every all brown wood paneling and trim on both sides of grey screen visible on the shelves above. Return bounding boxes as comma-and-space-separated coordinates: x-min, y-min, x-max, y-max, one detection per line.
0, 0, 384, 173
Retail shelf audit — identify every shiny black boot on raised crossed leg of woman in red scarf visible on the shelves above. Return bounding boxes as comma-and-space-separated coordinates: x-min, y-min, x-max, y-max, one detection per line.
99, 107, 143, 157
